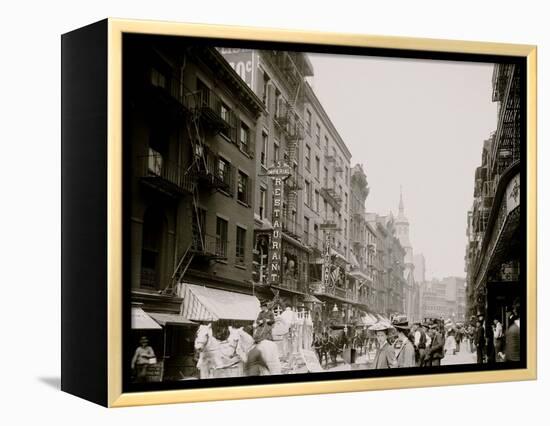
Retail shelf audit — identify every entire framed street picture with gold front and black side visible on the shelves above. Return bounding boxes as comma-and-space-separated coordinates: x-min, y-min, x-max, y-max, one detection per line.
62, 19, 536, 407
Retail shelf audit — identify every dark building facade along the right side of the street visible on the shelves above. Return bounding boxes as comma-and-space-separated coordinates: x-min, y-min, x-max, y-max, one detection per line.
465, 64, 525, 326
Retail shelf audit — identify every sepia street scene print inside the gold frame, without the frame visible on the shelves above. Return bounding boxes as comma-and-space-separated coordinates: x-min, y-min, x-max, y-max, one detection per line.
122, 35, 526, 387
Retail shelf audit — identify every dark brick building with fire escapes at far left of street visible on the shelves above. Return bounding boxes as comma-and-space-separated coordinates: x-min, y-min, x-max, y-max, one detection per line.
128, 36, 263, 379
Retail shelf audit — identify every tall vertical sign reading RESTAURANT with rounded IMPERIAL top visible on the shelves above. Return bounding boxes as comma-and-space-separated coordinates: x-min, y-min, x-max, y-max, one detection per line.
267, 161, 291, 285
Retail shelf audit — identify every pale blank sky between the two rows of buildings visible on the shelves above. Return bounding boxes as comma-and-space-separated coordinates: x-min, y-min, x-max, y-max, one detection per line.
309, 54, 497, 279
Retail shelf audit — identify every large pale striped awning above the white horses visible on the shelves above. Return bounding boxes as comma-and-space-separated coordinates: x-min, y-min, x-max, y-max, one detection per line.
179, 284, 260, 321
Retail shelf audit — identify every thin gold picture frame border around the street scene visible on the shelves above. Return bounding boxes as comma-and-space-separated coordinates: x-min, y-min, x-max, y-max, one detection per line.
62, 18, 537, 407
